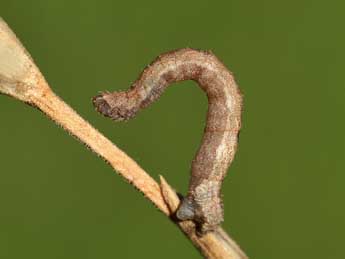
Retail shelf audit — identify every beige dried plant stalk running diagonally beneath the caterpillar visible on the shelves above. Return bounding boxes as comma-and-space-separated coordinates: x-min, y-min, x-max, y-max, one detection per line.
0, 18, 247, 259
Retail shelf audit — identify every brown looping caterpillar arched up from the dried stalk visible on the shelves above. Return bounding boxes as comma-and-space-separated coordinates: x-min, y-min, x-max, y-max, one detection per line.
93, 49, 242, 233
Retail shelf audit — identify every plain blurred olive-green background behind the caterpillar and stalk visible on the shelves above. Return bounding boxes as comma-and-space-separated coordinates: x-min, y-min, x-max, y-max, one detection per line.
0, 0, 345, 259
